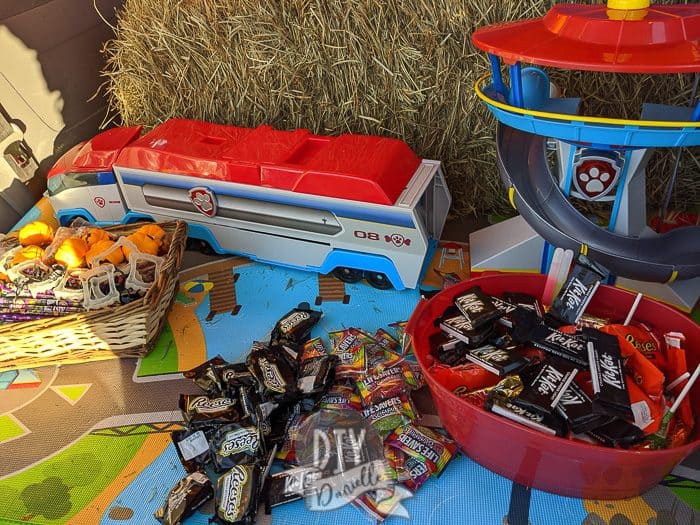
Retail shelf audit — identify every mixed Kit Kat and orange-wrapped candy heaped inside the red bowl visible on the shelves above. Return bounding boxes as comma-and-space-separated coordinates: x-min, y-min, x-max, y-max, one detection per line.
429, 256, 695, 449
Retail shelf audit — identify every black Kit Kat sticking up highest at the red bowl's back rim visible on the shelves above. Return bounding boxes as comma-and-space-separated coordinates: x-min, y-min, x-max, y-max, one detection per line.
547, 255, 608, 324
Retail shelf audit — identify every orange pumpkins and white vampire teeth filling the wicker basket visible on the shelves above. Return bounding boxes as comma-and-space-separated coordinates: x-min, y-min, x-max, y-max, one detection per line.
0, 221, 169, 322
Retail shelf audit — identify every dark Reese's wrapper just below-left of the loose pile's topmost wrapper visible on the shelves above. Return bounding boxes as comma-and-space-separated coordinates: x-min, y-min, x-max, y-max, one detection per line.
246, 345, 298, 399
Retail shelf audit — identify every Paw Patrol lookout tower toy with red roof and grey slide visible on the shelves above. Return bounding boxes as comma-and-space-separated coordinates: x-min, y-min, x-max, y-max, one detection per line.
470, 0, 700, 310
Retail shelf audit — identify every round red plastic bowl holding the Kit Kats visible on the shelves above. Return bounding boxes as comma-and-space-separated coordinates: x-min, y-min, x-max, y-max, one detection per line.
406, 274, 700, 499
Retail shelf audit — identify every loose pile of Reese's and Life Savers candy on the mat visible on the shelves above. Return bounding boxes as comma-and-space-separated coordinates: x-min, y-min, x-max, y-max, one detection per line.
163, 307, 457, 525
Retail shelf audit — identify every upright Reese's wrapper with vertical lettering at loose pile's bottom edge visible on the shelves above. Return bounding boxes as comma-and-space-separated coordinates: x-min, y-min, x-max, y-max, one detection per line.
215, 465, 260, 525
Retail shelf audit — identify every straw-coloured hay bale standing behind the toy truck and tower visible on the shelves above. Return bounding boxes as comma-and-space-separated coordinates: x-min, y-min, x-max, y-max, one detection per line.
104, 0, 700, 214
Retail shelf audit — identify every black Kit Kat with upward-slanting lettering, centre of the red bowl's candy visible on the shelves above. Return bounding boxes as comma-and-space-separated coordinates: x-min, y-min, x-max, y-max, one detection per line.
518, 356, 578, 412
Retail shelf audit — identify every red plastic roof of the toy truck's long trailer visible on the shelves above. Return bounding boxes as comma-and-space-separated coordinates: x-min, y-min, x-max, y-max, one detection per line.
113, 119, 420, 205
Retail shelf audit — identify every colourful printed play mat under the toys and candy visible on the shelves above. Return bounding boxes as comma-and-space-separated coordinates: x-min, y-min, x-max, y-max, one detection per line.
0, 199, 700, 525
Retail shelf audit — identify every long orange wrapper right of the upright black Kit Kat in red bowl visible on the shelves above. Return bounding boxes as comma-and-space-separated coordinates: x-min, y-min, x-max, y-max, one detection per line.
600, 325, 665, 400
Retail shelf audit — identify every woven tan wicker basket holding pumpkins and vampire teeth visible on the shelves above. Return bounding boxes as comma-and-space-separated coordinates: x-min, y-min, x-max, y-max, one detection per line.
0, 221, 187, 371
